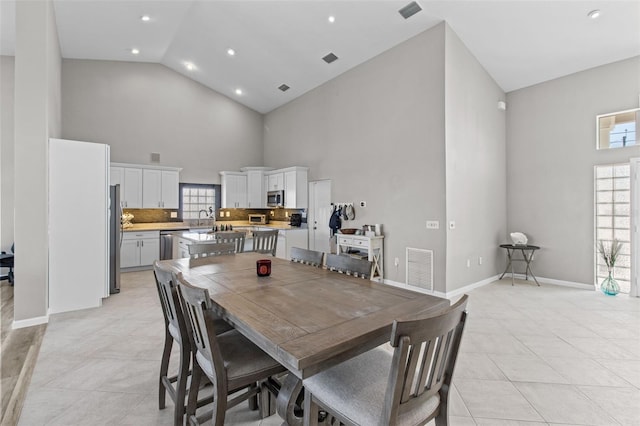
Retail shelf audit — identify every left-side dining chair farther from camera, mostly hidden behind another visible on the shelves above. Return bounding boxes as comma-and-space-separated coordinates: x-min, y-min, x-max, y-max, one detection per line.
153, 261, 232, 426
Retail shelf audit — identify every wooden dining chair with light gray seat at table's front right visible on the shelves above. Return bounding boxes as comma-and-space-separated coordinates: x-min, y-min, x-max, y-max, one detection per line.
303, 295, 468, 426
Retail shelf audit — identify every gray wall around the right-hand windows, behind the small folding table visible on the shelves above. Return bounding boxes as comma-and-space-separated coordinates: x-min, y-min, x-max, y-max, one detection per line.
507, 57, 640, 285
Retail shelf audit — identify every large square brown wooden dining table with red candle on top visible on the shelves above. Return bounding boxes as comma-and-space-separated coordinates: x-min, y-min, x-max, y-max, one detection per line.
160, 253, 450, 425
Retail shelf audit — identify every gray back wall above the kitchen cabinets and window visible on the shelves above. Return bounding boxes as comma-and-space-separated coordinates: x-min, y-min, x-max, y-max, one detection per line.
62, 59, 263, 183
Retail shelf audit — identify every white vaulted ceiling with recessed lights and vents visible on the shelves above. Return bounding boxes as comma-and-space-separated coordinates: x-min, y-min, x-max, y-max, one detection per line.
0, 0, 640, 113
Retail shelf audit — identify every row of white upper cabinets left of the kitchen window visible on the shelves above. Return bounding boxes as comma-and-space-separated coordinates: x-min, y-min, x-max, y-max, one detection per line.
110, 163, 180, 209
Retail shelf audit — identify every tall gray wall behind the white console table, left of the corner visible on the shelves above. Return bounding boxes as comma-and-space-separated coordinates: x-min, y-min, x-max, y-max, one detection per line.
264, 24, 446, 291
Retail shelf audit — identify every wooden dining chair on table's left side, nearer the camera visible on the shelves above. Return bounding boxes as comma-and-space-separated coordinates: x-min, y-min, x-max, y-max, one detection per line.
174, 273, 287, 426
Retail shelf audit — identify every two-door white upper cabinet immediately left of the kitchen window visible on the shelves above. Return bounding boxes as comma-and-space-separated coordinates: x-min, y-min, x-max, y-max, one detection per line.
142, 169, 180, 209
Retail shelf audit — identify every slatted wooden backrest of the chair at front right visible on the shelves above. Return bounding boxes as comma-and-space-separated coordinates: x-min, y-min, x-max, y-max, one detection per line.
383, 295, 468, 424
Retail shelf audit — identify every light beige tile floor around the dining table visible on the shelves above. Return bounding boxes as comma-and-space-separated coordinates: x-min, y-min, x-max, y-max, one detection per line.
19, 271, 640, 426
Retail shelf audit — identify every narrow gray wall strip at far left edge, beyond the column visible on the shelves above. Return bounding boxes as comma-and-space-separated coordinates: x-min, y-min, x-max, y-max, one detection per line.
0, 56, 15, 252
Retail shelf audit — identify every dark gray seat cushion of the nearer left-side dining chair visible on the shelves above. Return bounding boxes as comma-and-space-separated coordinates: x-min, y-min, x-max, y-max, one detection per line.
196, 330, 286, 392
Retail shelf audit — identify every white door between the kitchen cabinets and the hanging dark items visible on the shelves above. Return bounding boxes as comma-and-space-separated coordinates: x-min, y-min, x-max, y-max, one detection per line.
307, 180, 331, 253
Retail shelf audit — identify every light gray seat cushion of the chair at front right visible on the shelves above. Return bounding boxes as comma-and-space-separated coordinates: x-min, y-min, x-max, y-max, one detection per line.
303, 348, 440, 426
